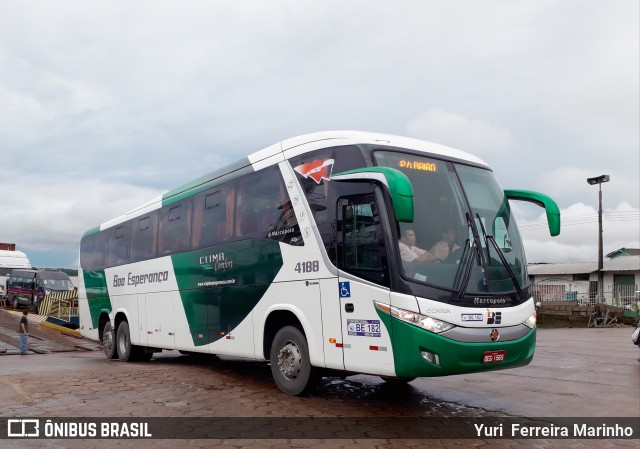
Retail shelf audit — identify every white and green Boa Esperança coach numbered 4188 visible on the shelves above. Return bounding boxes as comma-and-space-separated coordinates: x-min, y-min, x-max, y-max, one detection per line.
79, 131, 560, 395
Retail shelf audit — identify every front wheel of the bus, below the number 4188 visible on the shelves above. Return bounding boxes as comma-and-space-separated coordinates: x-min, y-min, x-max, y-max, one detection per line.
270, 326, 320, 396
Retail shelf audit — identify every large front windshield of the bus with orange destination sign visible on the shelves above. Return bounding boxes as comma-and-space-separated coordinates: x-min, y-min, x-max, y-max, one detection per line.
374, 151, 527, 299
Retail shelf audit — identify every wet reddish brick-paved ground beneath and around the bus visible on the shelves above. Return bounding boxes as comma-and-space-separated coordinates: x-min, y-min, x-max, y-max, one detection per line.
0, 311, 640, 449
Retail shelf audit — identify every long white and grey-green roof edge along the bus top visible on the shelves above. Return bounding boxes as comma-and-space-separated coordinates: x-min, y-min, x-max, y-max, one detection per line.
83, 131, 487, 237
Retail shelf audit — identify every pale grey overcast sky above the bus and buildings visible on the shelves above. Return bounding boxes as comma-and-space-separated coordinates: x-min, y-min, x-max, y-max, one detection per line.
0, 0, 640, 268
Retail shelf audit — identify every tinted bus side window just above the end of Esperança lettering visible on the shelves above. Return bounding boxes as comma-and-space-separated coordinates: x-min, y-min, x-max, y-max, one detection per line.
158, 201, 191, 255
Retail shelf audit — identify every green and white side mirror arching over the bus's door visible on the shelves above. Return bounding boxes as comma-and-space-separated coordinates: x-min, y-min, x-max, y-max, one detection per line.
331, 167, 414, 223
